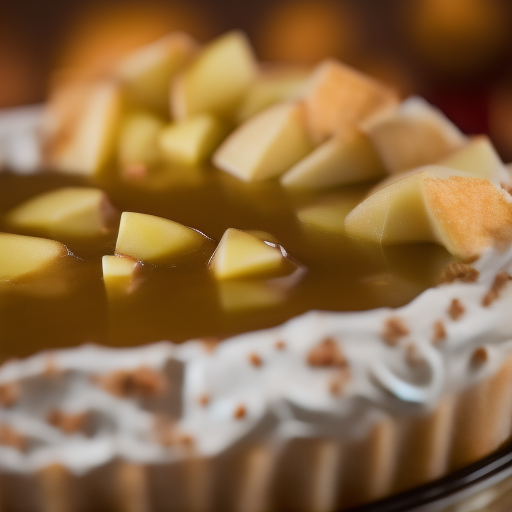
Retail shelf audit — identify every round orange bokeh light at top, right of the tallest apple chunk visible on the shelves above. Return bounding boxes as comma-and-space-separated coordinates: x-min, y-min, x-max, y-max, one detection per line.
256, 0, 358, 64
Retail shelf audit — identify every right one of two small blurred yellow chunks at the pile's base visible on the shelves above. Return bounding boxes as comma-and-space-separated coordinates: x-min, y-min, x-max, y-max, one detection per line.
158, 114, 227, 165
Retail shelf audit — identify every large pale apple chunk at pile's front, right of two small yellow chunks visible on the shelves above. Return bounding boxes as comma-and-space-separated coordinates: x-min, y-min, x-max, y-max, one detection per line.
213, 103, 313, 181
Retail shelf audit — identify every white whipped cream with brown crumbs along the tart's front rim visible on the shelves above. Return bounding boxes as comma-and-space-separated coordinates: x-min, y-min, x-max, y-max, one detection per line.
0, 108, 512, 474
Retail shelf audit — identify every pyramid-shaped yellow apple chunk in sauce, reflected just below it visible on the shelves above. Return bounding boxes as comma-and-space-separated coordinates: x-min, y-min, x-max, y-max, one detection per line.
210, 228, 284, 280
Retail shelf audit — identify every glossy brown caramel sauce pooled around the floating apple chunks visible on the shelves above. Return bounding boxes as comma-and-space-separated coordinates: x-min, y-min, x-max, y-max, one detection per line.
0, 168, 449, 360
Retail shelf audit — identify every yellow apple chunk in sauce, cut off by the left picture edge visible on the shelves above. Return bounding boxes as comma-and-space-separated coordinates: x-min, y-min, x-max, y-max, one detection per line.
0, 233, 69, 281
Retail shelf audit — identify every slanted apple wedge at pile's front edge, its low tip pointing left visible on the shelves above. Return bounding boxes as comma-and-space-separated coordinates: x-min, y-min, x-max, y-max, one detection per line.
280, 130, 386, 189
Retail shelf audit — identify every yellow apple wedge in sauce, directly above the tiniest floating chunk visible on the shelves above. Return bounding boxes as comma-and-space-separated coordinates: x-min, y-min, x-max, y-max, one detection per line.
116, 212, 209, 264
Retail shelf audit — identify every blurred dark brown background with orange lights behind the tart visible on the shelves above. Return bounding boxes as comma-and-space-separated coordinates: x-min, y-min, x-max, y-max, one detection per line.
0, 0, 512, 161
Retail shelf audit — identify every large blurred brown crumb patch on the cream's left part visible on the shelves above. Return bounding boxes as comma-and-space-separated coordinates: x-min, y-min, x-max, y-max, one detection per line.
97, 366, 167, 398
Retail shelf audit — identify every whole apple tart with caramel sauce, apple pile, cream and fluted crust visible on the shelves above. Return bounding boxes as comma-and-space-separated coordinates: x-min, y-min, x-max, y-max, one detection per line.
0, 32, 512, 512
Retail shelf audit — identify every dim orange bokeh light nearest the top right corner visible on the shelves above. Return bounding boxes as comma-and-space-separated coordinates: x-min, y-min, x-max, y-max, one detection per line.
403, 0, 507, 74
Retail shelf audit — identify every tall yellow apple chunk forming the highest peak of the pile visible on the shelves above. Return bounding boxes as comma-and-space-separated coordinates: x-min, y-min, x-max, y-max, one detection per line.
171, 31, 258, 120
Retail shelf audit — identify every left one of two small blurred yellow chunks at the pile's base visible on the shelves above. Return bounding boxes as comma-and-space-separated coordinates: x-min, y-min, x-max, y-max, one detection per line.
117, 111, 165, 168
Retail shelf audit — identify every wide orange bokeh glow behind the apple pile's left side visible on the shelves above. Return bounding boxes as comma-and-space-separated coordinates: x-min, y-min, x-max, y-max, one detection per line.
57, 2, 215, 77
